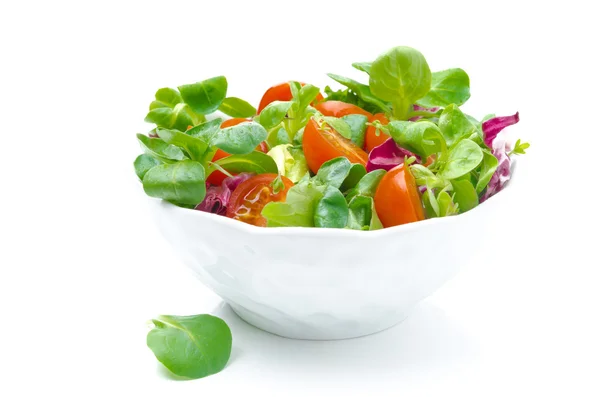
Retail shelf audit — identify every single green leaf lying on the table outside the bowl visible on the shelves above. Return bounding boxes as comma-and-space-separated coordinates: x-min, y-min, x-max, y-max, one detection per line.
146, 314, 232, 379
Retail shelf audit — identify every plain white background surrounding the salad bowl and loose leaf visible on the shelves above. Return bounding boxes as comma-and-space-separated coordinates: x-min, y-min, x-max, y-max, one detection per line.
0, 0, 600, 396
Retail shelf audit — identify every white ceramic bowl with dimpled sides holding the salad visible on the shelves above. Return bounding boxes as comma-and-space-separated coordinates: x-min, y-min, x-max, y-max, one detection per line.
146, 172, 510, 339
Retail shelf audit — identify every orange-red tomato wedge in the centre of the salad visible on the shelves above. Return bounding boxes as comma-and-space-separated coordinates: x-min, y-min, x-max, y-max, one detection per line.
302, 119, 369, 174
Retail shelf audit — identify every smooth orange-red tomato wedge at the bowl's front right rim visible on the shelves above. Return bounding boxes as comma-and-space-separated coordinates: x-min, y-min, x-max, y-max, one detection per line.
375, 163, 425, 227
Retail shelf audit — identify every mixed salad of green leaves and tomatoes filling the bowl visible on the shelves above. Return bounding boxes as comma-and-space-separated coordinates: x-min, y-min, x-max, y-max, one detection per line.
134, 47, 529, 230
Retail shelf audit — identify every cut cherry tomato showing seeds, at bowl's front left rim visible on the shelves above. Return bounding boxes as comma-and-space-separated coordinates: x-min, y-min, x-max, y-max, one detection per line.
226, 174, 294, 227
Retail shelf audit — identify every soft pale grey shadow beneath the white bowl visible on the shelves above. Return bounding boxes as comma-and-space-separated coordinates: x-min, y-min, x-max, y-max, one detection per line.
213, 301, 477, 377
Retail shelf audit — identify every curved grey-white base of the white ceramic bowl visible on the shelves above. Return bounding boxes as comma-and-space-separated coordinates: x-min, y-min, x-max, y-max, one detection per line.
229, 303, 406, 340
